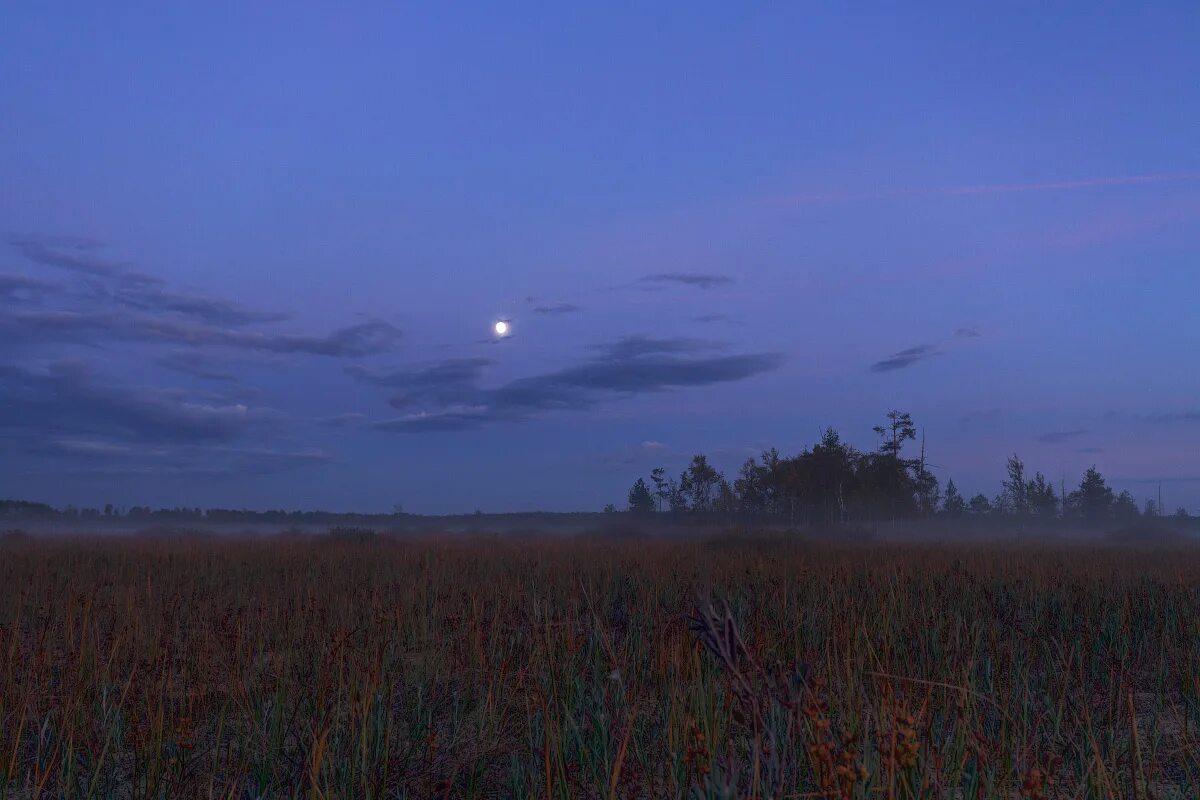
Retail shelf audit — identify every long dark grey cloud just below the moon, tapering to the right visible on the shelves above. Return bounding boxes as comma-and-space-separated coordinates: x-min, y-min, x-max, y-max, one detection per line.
373, 336, 784, 433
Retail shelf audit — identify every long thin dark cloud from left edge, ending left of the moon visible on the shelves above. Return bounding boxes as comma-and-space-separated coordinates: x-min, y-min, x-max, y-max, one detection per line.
0, 309, 401, 357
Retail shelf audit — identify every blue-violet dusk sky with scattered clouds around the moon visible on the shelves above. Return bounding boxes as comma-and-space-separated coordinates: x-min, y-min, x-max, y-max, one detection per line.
0, 0, 1200, 513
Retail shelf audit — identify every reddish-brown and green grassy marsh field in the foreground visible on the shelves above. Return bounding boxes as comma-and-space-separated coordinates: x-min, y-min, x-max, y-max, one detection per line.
0, 536, 1200, 800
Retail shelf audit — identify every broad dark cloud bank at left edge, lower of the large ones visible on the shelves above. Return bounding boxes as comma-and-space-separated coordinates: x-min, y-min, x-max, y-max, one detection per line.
0, 361, 280, 443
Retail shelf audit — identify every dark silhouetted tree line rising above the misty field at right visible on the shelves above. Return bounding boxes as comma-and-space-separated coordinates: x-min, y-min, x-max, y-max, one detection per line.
628, 410, 1188, 528
